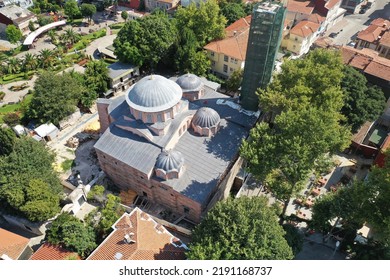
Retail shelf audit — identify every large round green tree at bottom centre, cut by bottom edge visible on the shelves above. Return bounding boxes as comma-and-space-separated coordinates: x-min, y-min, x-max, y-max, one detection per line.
187, 197, 293, 260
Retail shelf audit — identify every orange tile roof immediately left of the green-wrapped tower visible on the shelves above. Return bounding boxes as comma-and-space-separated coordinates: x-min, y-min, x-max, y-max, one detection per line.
204, 16, 252, 61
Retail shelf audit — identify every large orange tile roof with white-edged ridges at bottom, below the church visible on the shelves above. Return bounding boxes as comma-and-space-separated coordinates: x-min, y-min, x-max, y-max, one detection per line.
87, 208, 187, 260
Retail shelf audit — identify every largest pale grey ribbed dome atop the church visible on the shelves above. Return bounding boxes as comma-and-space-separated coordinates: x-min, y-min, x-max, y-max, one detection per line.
126, 75, 182, 112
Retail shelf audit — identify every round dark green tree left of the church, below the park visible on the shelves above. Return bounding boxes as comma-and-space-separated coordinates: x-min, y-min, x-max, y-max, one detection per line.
25, 72, 85, 124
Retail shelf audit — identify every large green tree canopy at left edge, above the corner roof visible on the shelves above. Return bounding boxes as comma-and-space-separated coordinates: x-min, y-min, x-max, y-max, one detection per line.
0, 138, 62, 221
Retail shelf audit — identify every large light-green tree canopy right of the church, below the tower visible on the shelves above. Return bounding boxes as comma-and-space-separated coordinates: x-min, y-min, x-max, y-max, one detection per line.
240, 50, 350, 217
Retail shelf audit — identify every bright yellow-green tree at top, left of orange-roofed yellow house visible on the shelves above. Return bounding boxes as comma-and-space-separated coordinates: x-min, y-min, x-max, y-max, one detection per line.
175, 0, 227, 46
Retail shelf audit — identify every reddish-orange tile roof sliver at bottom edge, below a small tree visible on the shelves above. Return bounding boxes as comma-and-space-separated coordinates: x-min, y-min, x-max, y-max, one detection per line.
30, 243, 81, 260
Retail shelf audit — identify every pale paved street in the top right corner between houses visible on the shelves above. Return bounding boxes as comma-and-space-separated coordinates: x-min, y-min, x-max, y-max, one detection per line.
325, 0, 390, 45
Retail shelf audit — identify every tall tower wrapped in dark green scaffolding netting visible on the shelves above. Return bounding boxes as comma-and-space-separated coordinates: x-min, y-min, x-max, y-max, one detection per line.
240, 2, 286, 111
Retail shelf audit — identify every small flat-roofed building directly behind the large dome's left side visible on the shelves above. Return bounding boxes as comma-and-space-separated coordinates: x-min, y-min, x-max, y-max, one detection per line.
105, 62, 139, 96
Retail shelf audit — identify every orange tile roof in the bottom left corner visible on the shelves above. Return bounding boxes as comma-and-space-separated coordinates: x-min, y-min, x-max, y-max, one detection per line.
0, 228, 30, 260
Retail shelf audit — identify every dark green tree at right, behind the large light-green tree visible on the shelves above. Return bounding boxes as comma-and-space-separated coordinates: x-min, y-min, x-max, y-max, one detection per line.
341, 66, 386, 132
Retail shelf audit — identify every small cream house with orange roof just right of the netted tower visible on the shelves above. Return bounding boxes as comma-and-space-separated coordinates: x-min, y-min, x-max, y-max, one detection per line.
283, 20, 320, 55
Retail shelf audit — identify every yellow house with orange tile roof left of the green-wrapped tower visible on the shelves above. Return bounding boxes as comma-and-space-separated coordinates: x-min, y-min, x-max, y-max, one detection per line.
204, 16, 252, 79
